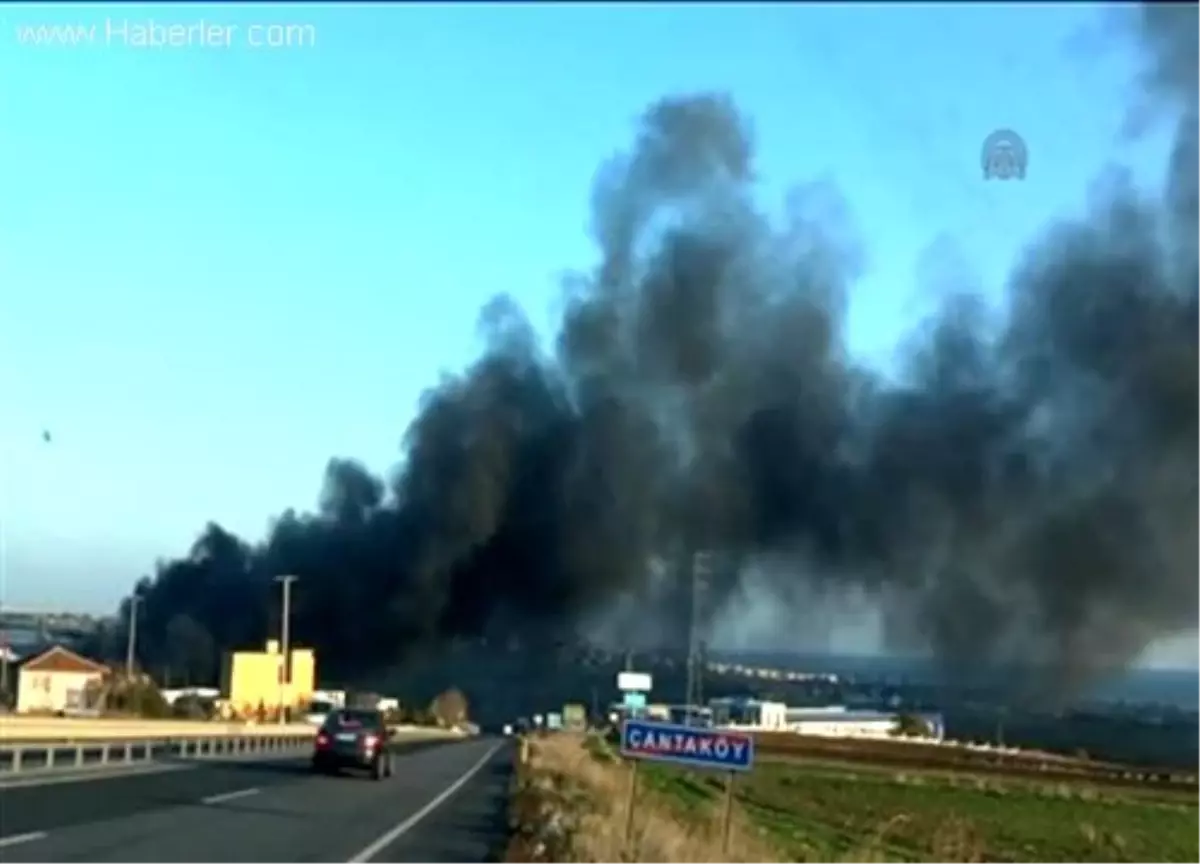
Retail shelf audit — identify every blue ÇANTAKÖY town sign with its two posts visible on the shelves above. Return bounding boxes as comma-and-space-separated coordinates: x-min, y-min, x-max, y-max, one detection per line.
620, 720, 754, 853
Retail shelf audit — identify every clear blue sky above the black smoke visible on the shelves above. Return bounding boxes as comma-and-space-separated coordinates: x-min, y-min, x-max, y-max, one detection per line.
0, 4, 1185, 667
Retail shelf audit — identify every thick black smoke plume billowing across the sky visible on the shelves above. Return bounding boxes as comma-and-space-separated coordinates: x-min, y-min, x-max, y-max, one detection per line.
110, 6, 1200, 696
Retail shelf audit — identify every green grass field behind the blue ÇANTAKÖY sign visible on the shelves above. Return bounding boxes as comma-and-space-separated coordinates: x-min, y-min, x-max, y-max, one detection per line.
642, 761, 1200, 864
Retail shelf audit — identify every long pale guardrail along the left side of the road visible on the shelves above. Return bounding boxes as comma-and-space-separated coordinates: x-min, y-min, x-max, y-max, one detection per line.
0, 732, 314, 779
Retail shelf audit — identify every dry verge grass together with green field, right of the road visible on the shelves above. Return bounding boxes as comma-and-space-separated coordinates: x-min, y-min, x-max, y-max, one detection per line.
506, 734, 1200, 864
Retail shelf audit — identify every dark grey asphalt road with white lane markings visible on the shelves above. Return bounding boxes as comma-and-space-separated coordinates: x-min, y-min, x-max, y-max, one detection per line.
0, 738, 511, 864
